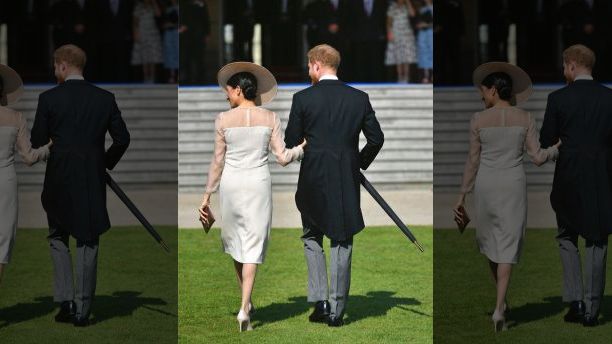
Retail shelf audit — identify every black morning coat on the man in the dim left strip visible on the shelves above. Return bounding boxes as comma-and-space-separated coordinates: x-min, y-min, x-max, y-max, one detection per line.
31, 80, 130, 240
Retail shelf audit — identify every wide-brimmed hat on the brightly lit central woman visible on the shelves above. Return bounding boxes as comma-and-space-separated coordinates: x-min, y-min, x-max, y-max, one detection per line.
217, 62, 277, 105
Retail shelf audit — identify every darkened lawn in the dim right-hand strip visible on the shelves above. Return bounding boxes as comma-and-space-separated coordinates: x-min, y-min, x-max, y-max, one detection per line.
434, 229, 612, 344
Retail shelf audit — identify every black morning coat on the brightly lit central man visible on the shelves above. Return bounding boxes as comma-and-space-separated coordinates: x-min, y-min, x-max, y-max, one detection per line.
285, 80, 384, 241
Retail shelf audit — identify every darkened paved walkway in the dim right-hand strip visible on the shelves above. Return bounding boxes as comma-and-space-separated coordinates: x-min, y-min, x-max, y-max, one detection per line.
434, 191, 557, 228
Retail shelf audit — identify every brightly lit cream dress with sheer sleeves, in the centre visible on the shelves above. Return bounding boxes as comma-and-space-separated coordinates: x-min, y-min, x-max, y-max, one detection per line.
206, 107, 304, 264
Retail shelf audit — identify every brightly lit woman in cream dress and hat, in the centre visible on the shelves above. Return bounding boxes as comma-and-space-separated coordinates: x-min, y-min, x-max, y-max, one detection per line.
200, 62, 305, 331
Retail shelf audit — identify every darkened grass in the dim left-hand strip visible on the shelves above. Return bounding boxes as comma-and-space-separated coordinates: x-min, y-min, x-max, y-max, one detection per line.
0, 227, 178, 344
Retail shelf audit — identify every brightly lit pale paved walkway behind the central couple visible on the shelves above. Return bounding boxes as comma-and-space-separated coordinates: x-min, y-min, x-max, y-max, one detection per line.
179, 188, 433, 228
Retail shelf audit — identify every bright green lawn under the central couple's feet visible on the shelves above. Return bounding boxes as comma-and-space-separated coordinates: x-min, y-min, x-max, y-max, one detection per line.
179, 227, 433, 344
